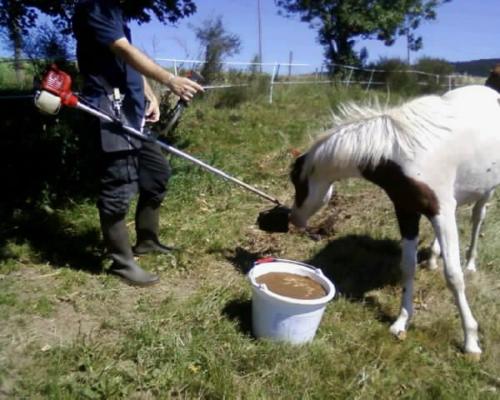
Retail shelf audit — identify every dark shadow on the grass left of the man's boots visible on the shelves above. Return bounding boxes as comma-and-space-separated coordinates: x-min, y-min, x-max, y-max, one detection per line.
0, 206, 103, 274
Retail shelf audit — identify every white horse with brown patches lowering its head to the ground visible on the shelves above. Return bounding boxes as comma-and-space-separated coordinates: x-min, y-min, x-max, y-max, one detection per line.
290, 85, 500, 359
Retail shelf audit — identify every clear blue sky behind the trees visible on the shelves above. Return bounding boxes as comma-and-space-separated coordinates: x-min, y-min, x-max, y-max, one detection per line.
132, 0, 500, 70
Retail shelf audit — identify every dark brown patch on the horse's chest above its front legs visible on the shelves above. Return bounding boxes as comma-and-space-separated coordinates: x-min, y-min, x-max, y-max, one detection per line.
361, 160, 439, 218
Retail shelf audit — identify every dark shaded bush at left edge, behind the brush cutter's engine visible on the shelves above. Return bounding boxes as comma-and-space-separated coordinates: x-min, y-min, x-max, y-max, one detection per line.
0, 91, 98, 211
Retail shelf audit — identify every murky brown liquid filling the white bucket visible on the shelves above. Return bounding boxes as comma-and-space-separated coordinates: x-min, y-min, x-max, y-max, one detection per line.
256, 272, 326, 300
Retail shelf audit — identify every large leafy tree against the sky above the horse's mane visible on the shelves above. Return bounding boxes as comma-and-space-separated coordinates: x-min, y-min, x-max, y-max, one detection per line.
275, 0, 451, 69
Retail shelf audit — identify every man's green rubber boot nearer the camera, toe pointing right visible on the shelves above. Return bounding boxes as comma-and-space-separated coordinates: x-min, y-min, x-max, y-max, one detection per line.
100, 213, 160, 286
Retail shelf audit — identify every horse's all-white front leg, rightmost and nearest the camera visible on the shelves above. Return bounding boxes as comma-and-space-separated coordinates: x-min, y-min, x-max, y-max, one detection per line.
431, 202, 481, 357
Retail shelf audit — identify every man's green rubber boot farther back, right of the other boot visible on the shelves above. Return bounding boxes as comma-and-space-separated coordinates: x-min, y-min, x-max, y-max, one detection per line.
133, 199, 175, 255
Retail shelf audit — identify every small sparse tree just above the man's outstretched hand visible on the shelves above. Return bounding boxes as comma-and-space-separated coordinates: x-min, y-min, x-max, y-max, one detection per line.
194, 16, 241, 82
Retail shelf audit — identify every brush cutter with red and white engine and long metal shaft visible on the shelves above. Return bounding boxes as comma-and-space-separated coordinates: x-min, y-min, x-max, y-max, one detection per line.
35, 66, 290, 232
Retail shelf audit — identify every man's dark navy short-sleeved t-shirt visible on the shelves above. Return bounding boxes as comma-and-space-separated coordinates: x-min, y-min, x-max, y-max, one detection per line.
73, 0, 145, 152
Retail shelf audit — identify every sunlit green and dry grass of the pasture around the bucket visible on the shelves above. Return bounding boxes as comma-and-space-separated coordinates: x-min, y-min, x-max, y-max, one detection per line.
0, 83, 500, 399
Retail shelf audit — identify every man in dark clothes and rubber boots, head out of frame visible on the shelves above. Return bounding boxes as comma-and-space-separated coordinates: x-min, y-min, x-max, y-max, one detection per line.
73, 0, 203, 286
